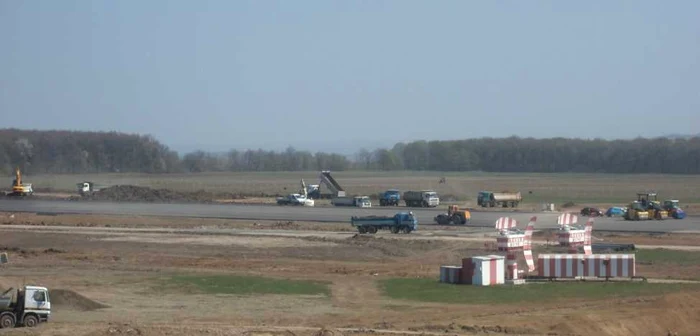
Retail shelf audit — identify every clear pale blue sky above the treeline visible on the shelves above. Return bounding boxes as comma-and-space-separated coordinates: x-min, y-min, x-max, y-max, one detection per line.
0, 0, 700, 153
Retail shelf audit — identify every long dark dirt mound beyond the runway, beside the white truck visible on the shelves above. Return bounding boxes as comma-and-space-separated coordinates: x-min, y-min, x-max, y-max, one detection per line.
73, 185, 243, 203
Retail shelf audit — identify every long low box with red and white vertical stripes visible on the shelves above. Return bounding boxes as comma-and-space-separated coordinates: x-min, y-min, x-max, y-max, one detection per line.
537, 254, 636, 278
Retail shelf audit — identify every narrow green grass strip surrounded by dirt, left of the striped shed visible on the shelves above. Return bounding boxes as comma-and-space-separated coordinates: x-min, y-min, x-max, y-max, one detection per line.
167, 275, 330, 296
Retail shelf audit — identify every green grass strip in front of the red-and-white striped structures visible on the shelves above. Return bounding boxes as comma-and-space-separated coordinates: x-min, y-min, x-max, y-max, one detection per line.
381, 279, 700, 304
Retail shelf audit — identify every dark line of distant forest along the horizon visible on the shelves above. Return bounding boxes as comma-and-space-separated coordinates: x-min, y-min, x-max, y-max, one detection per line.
0, 129, 700, 174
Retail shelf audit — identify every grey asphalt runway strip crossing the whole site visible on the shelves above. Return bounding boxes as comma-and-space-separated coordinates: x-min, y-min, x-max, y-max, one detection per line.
0, 199, 700, 232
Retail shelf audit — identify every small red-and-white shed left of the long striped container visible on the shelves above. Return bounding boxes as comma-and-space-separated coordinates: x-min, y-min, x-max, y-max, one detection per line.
461, 255, 505, 286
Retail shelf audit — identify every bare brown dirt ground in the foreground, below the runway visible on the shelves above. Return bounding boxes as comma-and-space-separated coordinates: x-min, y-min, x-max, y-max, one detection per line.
0, 213, 700, 336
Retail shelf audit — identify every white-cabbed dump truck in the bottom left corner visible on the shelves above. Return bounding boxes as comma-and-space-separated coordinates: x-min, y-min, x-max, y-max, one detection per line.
0, 286, 51, 329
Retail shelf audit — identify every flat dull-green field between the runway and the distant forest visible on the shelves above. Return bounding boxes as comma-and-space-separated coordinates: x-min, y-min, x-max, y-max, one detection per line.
19, 171, 700, 206
